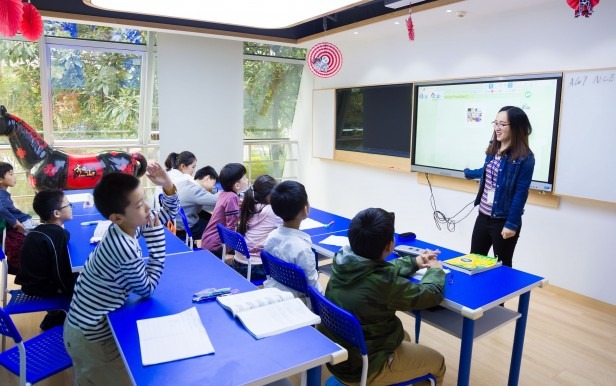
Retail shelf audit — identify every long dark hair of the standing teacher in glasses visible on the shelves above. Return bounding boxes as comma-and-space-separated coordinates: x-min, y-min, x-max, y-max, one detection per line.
486, 106, 533, 161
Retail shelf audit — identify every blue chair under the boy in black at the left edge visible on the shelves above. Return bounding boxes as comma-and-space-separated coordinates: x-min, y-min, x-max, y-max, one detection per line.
0, 248, 71, 351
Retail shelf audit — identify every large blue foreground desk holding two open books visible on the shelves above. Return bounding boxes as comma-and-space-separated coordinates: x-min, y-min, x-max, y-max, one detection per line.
109, 251, 347, 386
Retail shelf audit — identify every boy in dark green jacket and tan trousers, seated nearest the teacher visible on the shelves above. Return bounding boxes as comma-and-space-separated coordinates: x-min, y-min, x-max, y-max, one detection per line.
318, 208, 445, 385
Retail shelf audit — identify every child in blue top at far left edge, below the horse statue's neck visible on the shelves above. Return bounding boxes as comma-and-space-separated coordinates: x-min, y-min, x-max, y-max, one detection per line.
0, 162, 39, 275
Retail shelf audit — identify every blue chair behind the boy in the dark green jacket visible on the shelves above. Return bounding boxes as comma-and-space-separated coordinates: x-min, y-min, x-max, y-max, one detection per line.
308, 287, 436, 386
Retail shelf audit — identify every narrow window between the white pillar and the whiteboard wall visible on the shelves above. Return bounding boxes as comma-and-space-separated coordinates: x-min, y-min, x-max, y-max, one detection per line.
244, 43, 306, 180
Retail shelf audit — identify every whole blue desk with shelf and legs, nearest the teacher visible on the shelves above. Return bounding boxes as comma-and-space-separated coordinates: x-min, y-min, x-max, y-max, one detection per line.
312, 230, 547, 386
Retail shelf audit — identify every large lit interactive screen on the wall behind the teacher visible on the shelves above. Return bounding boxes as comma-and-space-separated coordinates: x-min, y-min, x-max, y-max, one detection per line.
411, 73, 562, 191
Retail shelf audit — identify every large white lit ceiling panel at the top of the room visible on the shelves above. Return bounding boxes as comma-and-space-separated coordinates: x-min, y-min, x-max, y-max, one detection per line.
83, 0, 365, 29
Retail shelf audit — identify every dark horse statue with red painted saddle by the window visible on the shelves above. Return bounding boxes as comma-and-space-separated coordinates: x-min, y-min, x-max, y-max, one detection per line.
0, 106, 147, 190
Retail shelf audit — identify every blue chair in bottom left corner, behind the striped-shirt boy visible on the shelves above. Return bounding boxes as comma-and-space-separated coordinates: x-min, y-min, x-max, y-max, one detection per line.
0, 308, 73, 386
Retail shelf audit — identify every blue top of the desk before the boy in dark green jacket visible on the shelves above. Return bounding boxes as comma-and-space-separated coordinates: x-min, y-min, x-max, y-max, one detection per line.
312, 230, 544, 319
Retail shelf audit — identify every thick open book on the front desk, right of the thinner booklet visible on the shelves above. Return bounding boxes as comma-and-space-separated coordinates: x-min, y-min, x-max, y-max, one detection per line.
216, 288, 321, 339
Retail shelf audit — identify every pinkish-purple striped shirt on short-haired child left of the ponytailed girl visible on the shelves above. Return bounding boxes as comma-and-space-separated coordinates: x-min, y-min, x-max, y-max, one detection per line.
201, 192, 240, 251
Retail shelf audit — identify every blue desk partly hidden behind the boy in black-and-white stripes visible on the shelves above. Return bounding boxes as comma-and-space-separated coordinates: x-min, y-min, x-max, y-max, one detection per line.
64, 212, 192, 272
